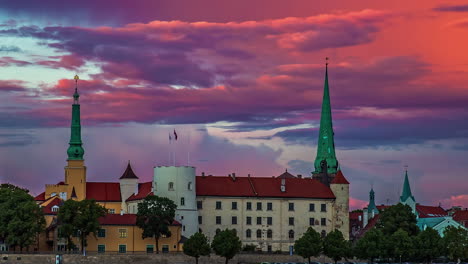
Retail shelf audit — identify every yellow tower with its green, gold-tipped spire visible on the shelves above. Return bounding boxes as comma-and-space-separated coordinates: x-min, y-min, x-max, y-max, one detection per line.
65, 75, 86, 201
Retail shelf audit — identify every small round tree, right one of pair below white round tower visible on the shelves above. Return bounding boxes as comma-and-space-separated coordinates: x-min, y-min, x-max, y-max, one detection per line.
211, 229, 242, 264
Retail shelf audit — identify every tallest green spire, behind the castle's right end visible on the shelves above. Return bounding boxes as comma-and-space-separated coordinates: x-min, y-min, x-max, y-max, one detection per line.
314, 58, 338, 174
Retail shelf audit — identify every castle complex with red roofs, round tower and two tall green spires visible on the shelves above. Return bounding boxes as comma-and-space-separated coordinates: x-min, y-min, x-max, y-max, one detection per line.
35, 63, 349, 252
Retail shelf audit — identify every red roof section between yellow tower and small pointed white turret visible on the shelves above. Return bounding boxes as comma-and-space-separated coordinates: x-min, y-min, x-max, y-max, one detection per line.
86, 182, 122, 202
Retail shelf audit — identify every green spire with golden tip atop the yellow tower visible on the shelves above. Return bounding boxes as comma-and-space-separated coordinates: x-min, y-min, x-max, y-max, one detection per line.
67, 75, 84, 160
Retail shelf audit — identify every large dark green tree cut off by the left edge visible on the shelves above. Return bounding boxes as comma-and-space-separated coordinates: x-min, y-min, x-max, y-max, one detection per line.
0, 184, 45, 251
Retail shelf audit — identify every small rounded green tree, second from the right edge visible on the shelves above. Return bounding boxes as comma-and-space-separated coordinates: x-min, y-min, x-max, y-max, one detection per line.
414, 227, 443, 263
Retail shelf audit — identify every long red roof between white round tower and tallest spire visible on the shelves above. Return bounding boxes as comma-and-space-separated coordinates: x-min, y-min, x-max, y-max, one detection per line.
196, 176, 335, 199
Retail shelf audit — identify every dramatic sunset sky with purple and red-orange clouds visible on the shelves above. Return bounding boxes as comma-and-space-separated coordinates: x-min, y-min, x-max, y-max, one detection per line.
0, 0, 468, 209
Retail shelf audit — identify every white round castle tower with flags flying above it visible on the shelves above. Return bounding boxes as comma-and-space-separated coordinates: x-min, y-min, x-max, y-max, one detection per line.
153, 166, 198, 237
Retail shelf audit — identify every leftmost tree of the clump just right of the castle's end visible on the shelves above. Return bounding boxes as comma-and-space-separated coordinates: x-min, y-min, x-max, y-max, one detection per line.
354, 228, 385, 264
